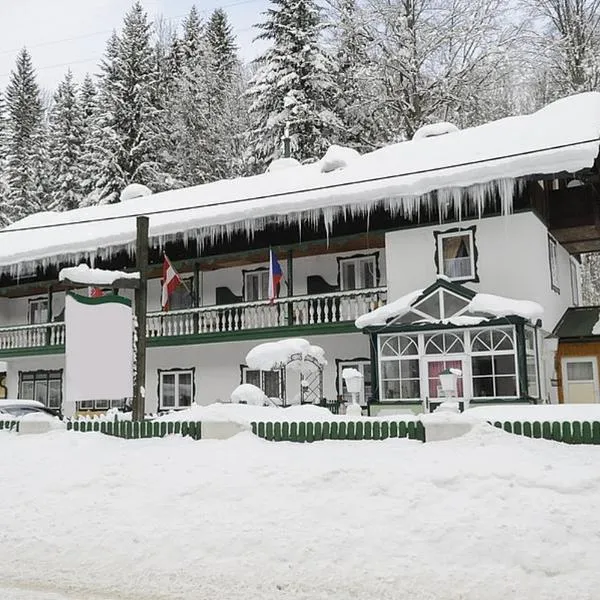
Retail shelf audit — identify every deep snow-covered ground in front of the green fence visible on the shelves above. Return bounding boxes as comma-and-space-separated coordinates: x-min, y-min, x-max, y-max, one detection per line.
0, 426, 600, 600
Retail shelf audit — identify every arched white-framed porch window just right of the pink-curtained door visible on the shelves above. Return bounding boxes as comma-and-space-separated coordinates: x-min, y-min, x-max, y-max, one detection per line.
471, 328, 518, 398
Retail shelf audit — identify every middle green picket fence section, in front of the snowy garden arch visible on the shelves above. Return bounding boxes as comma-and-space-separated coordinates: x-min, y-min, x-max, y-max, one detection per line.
252, 421, 425, 442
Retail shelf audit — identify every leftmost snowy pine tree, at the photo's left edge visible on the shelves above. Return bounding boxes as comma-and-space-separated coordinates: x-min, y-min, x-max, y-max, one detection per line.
4, 48, 46, 222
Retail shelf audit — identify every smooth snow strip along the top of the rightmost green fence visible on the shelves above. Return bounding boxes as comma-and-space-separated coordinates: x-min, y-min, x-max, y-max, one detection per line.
464, 404, 600, 421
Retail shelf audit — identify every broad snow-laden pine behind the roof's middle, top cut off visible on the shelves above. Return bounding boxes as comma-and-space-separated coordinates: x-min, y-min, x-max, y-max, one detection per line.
248, 0, 341, 171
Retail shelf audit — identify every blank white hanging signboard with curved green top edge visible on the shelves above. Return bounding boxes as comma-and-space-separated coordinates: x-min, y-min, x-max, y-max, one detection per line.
65, 294, 133, 402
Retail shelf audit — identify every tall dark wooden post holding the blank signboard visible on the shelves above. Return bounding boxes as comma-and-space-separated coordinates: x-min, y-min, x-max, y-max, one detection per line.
133, 217, 149, 421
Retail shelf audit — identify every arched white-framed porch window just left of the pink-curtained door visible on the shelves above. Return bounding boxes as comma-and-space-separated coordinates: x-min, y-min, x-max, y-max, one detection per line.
379, 335, 421, 401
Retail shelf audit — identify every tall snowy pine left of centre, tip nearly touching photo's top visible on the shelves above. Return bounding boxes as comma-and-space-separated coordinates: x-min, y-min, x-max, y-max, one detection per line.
97, 1, 158, 203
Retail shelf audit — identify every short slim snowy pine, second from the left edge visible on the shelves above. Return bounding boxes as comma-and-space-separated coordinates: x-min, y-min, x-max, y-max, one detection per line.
48, 71, 83, 210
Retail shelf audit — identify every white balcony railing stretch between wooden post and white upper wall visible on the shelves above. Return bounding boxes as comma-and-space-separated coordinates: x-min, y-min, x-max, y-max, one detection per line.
147, 287, 387, 337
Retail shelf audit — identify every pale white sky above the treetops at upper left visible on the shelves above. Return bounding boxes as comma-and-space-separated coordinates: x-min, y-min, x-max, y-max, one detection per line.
0, 0, 268, 89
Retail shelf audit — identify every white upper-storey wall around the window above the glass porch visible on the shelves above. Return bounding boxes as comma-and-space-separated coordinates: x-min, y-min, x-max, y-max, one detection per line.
386, 212, 571, 331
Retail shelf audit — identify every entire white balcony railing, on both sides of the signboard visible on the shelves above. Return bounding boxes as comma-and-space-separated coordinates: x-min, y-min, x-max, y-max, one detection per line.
0, 287, 387, 351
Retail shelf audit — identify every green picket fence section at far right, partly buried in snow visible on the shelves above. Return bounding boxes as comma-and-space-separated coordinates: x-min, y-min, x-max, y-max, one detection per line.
491, 421, 600, 444
